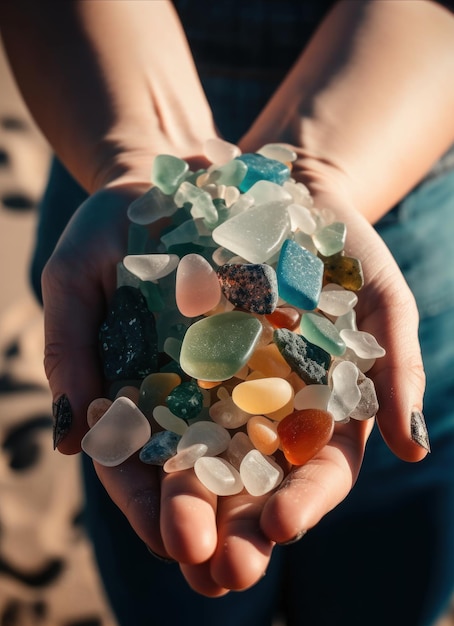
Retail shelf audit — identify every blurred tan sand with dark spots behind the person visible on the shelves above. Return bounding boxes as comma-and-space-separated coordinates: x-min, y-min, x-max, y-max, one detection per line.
0, 30, 454, 626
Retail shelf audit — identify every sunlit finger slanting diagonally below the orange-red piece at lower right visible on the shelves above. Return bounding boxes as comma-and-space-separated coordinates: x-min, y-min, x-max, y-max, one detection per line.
260, 420, 373, 543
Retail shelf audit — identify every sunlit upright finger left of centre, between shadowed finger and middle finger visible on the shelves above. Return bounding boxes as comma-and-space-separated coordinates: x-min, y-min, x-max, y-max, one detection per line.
161, 469, 217, 564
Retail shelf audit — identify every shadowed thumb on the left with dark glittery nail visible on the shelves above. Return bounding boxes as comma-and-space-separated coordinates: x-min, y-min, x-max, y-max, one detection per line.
42, 185, 143, 454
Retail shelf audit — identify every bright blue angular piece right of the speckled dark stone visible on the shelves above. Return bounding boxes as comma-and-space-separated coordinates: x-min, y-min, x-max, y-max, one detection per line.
276, 239, 323, 311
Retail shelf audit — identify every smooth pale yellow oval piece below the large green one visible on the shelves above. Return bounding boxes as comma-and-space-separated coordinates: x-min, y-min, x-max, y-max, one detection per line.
232, 377, 293, 415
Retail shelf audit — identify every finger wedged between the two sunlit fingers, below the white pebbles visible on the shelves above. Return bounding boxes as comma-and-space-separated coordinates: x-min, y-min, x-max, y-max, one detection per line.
210, 493, 274, 591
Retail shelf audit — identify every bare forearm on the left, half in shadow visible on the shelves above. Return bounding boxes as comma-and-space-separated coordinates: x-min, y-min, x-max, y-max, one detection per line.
0, 0, 213, 192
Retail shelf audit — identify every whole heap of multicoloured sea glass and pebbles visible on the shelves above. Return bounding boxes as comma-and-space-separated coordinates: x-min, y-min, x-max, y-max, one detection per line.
82, 139, 385, 496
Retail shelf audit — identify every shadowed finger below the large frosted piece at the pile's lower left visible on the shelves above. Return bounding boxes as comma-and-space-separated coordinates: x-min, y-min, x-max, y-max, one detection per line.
94, 455, 169, 558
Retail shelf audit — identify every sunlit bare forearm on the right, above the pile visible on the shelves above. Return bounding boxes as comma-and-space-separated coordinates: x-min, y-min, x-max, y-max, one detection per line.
245, 0, 454, 222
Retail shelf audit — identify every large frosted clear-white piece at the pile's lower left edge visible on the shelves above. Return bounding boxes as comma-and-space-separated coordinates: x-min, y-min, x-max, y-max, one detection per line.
81, 397, 151, 467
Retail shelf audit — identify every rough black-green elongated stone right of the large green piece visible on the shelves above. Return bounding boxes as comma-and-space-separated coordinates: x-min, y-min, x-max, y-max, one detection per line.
273, 328, 331, 385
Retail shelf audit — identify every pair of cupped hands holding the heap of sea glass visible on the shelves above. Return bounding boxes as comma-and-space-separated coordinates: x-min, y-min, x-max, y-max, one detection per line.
43, 118, 426, 597
